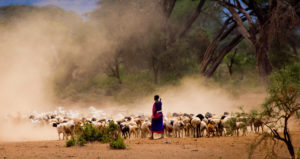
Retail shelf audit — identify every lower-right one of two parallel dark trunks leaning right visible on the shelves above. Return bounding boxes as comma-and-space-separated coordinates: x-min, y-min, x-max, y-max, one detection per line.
206, 35, 243, 78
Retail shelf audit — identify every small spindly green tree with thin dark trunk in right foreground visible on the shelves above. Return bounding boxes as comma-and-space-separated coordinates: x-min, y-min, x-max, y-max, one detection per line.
249, 67, 300, 159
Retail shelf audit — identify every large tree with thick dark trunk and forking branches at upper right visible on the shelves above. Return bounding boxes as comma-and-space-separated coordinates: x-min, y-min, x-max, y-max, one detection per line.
216, 0, 299, 79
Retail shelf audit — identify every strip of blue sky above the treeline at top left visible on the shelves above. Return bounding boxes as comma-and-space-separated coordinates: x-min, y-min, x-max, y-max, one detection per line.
0, 0, 99, 15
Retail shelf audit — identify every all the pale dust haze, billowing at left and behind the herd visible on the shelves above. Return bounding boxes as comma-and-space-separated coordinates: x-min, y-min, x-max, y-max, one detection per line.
0, 4, 265, 141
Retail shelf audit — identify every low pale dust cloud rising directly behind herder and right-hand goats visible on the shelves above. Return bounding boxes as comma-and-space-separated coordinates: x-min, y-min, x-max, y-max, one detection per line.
127, 77, 266, 115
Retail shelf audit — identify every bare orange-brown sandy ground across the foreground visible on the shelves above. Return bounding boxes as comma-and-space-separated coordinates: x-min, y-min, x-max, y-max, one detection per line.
0, 131, 300, 159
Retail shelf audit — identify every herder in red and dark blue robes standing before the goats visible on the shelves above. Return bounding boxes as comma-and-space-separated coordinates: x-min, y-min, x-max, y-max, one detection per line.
150, 95, 164, 139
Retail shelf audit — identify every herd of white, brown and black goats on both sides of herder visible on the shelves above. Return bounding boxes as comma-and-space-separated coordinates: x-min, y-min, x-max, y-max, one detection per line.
12, 108, 263, 140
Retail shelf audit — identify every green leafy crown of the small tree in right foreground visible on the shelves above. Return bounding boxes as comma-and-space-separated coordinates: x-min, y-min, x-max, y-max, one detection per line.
263, 65, 300, 118
